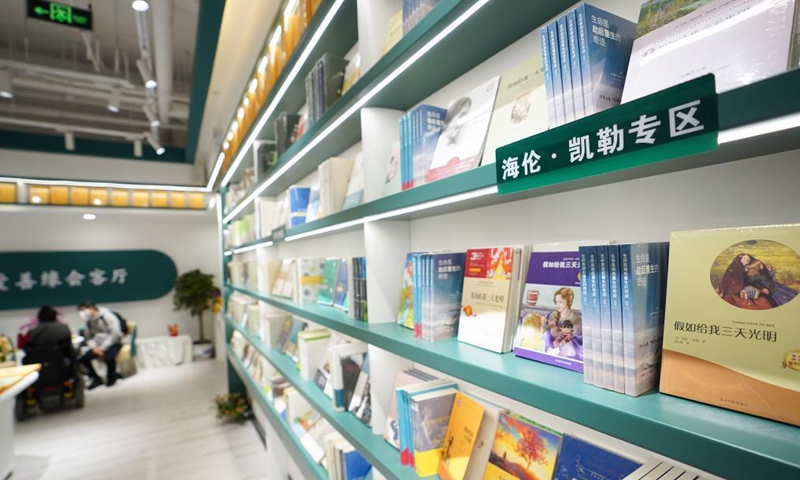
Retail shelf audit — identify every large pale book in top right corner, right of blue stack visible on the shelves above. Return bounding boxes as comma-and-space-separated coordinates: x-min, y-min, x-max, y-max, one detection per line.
622, 0, 795, 102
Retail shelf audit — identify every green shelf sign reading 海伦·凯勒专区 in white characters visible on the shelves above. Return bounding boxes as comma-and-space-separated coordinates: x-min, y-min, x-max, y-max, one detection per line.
496, 75, 719, 195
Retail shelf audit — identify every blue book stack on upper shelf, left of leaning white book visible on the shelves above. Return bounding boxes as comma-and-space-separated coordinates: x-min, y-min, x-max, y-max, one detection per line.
400, 105, 447, 190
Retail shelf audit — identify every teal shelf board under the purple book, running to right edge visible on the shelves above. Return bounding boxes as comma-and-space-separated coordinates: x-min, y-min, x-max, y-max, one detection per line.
225, 287, 800, 478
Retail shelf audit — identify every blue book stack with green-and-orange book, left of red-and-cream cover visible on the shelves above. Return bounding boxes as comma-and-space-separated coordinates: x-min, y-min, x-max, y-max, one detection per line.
397, 253, 465, 341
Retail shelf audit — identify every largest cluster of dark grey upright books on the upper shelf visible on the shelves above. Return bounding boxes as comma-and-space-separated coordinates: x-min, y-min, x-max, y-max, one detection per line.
306, 53, 347, 126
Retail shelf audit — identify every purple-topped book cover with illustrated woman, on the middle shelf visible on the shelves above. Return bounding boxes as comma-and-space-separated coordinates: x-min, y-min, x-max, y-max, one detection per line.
514, 247, 584, 372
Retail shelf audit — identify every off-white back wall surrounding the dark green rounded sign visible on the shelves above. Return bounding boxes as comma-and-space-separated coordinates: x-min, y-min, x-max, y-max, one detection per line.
0, 207, 221, 339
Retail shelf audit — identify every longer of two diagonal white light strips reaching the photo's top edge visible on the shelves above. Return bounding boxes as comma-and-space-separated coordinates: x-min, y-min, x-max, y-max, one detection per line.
223, 0, 490, 223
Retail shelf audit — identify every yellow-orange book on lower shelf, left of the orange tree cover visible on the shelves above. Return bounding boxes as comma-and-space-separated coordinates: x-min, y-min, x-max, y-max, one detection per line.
437, 392, 483, 480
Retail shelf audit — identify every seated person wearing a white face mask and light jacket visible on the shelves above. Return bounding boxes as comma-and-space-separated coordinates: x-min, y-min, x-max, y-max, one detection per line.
78, 300, 122, 390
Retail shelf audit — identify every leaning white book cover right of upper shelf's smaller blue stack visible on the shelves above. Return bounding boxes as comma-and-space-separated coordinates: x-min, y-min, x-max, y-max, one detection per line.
426, 77, 500, 182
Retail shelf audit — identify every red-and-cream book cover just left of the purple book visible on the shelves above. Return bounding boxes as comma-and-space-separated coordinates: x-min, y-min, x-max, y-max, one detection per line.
458, 247, 519, 353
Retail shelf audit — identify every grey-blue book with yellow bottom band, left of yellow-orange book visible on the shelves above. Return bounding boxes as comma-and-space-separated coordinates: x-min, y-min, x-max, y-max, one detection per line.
410, 388, 457, 477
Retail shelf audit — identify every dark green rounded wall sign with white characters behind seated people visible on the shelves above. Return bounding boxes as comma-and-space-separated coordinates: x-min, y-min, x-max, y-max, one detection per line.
0, 250, 178, 310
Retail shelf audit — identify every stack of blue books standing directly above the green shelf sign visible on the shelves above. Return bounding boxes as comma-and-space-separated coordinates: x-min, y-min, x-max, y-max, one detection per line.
541, 3, 636, 128
